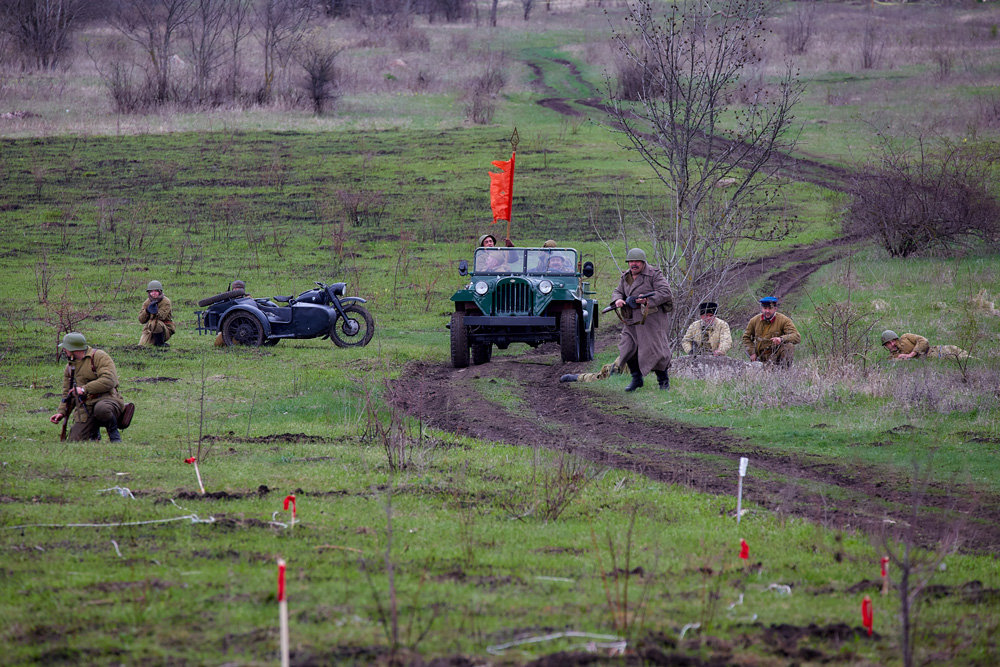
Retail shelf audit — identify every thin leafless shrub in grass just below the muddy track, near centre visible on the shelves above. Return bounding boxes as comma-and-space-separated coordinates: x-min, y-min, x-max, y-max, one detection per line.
504, 447, 603, 522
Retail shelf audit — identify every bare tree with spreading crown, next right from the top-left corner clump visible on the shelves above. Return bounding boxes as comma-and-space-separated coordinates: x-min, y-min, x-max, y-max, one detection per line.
110, 0, 194, 104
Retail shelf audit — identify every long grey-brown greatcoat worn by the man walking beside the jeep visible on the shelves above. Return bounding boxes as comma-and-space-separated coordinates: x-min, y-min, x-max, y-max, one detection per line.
611, 263, 674, 375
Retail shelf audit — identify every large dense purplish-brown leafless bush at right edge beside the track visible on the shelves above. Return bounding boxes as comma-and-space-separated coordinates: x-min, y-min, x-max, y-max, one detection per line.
845, 124, 1000, 257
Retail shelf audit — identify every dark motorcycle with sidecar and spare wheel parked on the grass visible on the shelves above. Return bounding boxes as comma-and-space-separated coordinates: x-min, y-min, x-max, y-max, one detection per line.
196, 283, 374, 347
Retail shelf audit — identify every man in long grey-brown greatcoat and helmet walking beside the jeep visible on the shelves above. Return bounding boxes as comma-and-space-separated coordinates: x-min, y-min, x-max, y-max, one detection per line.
611, 248, 674, 391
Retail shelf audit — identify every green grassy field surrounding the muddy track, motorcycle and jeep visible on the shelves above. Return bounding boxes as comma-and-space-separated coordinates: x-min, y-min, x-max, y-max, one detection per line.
0, 0, 1000, 665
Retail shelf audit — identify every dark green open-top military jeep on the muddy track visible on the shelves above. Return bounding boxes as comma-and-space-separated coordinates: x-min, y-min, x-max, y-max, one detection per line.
448, 248, 597, 368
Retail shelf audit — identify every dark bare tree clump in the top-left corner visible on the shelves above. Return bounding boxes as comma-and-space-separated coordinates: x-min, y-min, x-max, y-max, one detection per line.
0, 0, 90, 69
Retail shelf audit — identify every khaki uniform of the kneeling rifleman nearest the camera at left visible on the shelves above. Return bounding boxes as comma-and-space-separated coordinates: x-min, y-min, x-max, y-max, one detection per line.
59, 346, 125, 440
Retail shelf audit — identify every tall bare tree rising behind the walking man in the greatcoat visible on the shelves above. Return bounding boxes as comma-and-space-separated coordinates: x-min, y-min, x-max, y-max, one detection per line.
608, 0, 803, 326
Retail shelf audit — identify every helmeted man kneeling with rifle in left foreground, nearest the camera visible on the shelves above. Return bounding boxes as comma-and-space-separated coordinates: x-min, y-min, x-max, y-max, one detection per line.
49, 332, 125, 442
